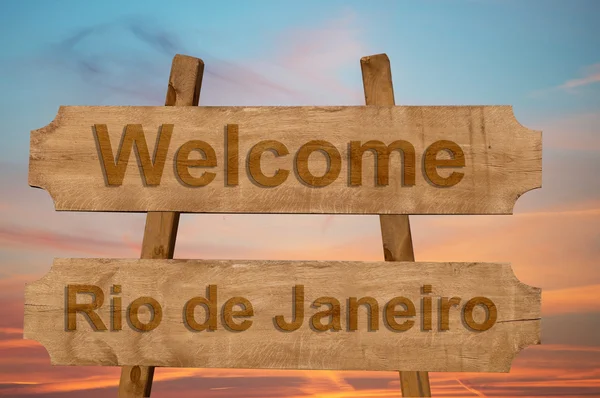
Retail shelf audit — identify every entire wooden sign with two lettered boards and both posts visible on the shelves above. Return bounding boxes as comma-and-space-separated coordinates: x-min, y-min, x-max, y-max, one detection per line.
24, 54, 542, 398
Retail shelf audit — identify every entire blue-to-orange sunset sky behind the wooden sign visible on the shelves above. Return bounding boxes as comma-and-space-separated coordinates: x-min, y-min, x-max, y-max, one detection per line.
0, 0, 600, 398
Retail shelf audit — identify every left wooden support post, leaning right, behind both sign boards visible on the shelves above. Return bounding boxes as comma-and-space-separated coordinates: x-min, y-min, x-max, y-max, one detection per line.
119, 54, 204, 398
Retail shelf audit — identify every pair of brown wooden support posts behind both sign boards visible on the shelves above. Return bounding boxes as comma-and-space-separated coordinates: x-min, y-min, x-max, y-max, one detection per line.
119, 54, 431, 398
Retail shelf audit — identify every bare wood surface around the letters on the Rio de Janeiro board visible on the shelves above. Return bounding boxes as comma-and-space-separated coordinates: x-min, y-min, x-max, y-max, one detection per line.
24, 259, 541, 372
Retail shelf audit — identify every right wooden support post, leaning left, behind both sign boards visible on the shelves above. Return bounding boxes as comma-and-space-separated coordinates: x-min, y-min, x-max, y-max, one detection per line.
360, 54, 431, 397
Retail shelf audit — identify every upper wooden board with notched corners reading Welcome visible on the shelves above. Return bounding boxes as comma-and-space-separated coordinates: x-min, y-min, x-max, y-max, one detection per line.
29, 106, 542, 214
